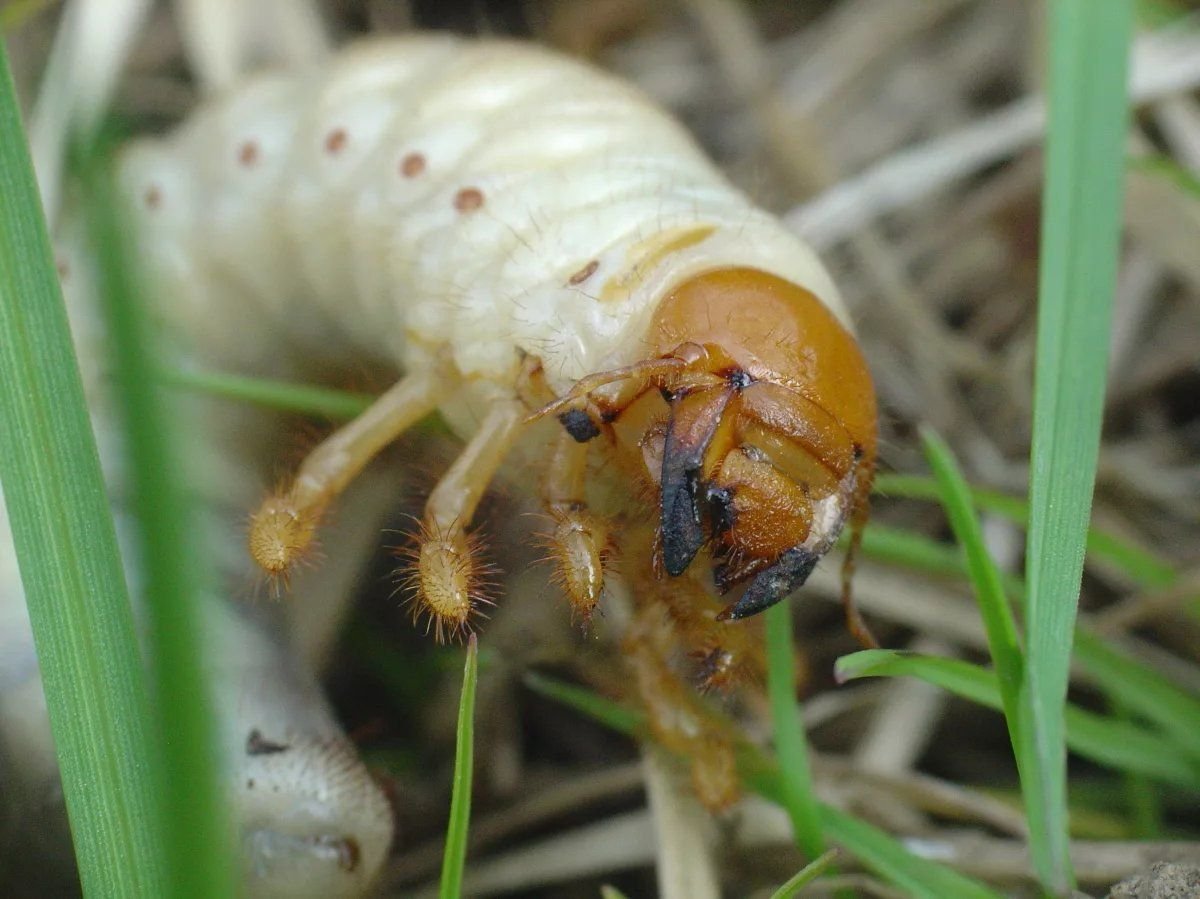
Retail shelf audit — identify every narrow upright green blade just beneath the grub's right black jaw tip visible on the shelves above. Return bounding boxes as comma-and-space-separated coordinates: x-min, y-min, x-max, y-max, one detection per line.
766, 601, 824, 858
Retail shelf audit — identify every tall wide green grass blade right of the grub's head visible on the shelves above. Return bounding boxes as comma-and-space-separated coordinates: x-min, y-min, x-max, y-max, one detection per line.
1020, 0, 1134, 894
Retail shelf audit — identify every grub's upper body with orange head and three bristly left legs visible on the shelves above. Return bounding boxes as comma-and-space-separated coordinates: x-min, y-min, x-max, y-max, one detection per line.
121, 36, 875, 631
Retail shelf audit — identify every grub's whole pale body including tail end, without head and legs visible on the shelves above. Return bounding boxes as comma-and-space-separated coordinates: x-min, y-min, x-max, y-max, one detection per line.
0, 36, 845, 895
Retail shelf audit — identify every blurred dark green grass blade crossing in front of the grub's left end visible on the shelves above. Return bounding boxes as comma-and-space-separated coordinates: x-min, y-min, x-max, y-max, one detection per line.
85, 145, 235, 895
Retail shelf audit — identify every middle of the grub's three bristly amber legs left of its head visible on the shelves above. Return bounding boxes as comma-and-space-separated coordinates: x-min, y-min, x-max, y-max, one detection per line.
410, 400, 524, 641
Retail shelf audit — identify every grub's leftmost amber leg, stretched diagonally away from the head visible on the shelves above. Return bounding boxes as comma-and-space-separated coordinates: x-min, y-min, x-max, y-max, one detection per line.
248, 368, 452, 577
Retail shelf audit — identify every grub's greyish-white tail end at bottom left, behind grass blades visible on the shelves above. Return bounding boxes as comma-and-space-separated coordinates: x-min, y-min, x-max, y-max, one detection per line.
0, 497, 392, 899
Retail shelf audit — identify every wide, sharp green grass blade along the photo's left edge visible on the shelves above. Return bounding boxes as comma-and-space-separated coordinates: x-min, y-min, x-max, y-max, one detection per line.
0, 44, 164, 897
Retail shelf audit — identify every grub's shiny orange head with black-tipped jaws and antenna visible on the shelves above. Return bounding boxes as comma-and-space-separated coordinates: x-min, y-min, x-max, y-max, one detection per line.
549, 262, 876, 619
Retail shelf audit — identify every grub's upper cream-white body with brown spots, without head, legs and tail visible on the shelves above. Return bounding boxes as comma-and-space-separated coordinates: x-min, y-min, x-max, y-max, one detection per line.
121, 36, 845, 434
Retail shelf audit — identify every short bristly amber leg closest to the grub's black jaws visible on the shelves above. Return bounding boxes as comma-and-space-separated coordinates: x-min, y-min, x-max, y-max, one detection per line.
542, 431, 607, 625
